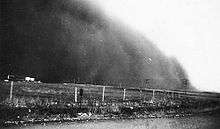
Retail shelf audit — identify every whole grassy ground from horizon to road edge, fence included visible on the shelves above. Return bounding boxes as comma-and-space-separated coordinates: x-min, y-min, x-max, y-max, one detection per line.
0, 82, 220, 126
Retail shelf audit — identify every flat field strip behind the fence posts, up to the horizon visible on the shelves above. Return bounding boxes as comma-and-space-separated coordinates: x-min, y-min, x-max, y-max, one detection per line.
0, 82, 220, 101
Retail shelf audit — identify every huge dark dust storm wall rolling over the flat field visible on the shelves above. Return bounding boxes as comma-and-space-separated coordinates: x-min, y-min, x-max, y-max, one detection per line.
0, 0, 192, 89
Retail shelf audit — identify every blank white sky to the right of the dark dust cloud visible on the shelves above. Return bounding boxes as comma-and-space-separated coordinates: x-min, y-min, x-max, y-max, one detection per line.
93, 0, 220, 92
